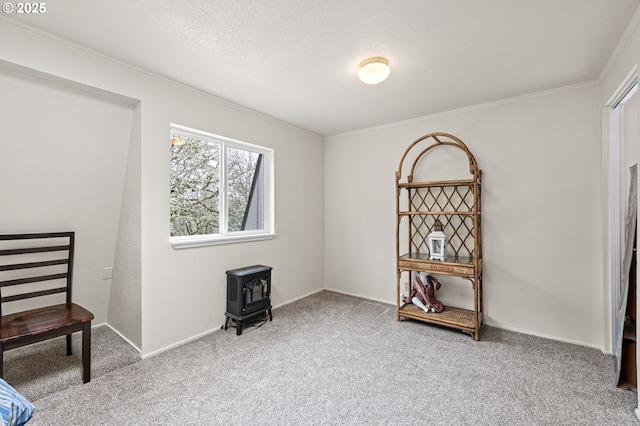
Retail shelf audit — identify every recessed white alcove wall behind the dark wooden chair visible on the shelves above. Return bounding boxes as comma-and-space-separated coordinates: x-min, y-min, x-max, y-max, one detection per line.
0, 63, 133, 324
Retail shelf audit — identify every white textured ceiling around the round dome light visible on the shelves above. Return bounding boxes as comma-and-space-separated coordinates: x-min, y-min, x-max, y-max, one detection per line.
0, 0, 640, 135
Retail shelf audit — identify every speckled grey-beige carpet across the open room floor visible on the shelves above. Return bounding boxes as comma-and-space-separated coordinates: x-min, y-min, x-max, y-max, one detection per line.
6, 291, 640, 426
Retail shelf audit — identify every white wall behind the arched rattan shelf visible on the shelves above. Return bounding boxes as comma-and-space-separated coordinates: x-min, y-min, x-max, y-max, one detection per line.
325, 84, 604, 348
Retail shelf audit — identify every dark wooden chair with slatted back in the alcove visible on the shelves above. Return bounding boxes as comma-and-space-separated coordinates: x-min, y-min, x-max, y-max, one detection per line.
0, 232, 93, 383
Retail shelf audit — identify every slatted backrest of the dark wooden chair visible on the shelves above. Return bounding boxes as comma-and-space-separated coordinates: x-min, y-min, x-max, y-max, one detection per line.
0, 232, 75, 315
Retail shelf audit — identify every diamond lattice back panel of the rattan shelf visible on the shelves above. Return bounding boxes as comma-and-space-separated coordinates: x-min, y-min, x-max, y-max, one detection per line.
409, 184, 475, 258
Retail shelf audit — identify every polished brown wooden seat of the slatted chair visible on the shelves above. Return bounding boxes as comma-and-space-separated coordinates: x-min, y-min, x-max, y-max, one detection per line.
0, 303, 93, 343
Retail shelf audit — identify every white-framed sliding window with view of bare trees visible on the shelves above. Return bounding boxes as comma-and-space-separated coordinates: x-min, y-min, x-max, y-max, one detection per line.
170, 125, 274, 248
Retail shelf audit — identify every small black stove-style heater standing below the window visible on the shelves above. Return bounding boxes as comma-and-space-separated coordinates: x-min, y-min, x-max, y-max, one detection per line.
223, 265, 273, 336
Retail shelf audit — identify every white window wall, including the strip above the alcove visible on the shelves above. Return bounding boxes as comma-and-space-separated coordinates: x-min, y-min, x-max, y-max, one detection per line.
0, 21, 323, 356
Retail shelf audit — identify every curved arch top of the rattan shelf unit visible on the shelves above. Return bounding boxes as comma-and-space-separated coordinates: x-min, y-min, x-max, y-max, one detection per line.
396, 132, 481, 183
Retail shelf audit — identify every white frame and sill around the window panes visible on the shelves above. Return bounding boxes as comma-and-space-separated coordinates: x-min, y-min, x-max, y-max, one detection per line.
169, 123, 276, 249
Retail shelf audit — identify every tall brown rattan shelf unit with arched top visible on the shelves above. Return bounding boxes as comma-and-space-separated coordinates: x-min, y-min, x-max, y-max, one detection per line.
396, 133, 482, 340
